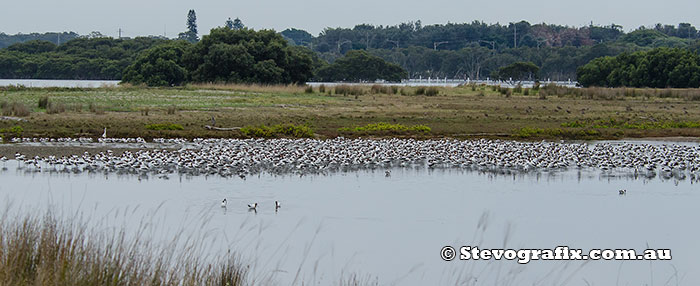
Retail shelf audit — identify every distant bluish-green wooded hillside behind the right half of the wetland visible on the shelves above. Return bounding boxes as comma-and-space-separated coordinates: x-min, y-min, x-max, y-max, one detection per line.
281, 21, 699, 80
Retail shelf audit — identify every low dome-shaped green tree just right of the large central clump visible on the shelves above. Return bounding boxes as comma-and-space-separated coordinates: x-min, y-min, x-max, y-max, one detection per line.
316, 51, 408, 82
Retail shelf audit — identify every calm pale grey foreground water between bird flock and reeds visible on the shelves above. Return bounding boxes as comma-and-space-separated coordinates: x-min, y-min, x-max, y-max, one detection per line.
0, 161, 700, 285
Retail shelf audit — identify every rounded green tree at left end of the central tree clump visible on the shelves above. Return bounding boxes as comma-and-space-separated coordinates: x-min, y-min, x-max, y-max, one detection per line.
122, 41, 189, 86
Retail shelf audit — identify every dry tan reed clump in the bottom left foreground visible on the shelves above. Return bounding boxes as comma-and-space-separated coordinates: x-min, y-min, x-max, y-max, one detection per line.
0, 212, 247, 286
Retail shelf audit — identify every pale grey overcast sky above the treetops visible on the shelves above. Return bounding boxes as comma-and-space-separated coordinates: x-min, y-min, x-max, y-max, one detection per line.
0, 0, 700, 37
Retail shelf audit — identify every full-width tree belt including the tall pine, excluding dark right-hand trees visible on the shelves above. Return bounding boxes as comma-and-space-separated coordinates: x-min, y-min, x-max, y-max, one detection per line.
0, 14, 700, 85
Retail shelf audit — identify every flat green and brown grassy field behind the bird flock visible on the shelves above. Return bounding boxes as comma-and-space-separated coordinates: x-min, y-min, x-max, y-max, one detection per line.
0, 84, 700, 140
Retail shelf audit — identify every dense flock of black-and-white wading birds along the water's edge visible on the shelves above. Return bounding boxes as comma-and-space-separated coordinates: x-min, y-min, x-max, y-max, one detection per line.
0, 138, 700, 188
